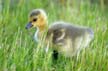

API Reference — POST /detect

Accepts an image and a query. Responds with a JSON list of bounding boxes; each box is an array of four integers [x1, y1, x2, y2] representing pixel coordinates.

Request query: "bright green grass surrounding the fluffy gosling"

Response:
[[0, 0, 108, 71]]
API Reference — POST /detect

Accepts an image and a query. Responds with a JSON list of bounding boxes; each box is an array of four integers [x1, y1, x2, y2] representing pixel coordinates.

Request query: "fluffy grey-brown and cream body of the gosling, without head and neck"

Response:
[[47, 22, 94, 57]]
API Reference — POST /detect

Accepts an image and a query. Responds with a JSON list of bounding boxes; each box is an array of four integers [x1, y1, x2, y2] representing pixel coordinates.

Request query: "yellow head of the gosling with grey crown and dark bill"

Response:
[[26, 9, 47, 31]]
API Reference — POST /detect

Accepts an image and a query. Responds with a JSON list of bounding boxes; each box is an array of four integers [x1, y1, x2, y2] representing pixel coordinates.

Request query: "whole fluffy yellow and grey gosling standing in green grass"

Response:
[[26, 9, 94, 57]]
